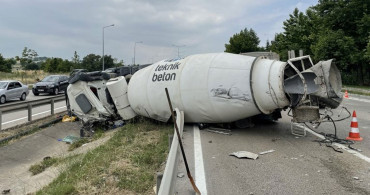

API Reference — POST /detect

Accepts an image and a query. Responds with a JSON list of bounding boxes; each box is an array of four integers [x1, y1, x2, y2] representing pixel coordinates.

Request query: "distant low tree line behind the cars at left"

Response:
[[0, 47, 123, 73]]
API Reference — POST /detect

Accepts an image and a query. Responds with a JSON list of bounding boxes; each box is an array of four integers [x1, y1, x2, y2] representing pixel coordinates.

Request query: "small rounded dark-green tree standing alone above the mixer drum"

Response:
[[225, 28, 260, 54]]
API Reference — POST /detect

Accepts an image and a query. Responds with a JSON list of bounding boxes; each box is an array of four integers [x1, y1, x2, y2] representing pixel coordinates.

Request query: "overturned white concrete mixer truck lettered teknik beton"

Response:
[[67, 53, 342, 136]]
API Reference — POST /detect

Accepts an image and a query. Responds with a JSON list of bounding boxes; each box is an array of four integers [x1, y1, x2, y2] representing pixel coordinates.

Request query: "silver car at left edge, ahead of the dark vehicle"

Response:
[[0, 80, 29, 104]]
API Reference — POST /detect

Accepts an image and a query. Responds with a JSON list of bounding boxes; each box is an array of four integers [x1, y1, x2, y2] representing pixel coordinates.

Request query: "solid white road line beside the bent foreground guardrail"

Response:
[[193, 125, 207, 195]]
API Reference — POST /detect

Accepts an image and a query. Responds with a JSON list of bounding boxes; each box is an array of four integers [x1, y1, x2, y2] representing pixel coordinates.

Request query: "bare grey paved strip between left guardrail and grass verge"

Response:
[[0, 122, 81, 194]]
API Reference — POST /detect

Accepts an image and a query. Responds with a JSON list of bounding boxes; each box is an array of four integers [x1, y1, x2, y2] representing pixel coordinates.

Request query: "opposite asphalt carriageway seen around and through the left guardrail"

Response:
[[0, 91, 66, 129]]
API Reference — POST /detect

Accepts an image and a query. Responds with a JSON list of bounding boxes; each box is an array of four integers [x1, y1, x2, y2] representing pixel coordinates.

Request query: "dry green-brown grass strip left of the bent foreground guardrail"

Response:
[[37, 120, 173, 194]]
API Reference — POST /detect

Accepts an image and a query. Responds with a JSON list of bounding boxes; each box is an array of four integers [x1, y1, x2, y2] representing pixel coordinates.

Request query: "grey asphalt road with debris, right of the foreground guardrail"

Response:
[[176, 96, 370, 195]]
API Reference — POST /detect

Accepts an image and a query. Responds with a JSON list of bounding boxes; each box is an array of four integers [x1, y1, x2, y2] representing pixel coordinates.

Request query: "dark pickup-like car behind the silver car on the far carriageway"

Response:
[[32, 75, 69, 95]]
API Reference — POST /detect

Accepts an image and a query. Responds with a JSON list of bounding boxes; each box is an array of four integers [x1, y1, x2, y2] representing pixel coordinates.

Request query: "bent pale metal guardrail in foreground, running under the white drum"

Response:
[[158, 108, 184, 195]]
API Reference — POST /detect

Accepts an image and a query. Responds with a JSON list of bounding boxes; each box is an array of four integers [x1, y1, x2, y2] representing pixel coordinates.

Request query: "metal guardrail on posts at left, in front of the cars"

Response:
[[0, 95, 65, 131]]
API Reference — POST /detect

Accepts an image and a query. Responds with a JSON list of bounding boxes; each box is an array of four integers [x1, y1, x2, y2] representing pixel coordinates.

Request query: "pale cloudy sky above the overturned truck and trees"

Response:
[[0, 0, 317, 64]]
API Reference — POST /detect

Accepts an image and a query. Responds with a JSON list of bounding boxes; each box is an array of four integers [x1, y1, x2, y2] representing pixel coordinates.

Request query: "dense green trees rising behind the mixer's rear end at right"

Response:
[[225, 0, 370, 85]]
